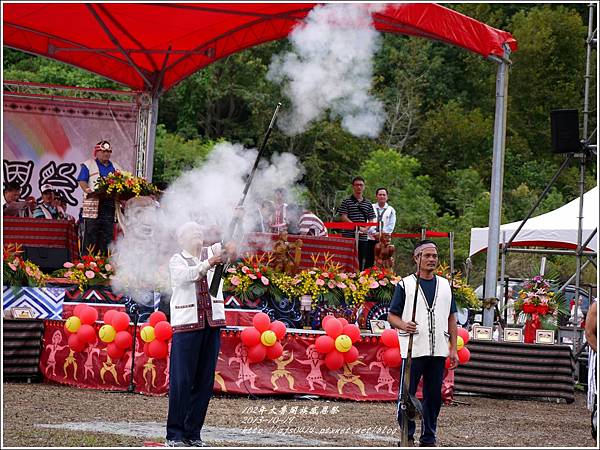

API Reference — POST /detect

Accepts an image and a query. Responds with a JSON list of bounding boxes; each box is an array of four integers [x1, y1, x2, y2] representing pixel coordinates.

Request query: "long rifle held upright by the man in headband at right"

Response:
[[397, 255, 423, 447]]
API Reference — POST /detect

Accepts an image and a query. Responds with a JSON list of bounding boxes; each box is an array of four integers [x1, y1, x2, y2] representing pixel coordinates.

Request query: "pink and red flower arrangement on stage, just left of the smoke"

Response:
[[52, 253, 114, 292]]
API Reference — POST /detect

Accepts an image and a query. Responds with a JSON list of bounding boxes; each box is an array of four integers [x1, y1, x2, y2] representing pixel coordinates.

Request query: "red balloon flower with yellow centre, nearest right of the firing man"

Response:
[[240, 312, 286, 363]]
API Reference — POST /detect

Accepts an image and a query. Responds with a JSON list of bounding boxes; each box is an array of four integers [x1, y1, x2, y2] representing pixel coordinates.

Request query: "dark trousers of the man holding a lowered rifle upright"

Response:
[[400, 356, 446, 444]]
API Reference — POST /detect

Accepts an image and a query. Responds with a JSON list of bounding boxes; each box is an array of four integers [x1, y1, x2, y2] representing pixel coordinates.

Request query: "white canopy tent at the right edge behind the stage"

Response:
[[469, 186, 598, 256]]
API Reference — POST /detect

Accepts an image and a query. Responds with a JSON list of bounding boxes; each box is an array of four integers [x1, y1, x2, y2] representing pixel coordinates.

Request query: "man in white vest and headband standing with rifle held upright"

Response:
[[388, 240, 458, 447]]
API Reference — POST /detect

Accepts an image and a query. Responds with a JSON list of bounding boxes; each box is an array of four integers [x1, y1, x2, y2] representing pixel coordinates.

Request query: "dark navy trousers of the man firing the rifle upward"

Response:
[[167, 327, 221, 441]]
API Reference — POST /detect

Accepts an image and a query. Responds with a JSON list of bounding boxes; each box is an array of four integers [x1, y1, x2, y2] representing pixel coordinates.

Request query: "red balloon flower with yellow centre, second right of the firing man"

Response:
[[315, 316, 361, 370]]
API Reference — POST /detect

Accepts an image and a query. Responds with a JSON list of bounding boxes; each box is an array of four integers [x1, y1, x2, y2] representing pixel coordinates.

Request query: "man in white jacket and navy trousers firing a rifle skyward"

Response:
[[166, 222, 235, 447]]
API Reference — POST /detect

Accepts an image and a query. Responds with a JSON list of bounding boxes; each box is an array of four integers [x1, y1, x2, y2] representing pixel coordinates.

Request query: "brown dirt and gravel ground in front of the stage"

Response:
[[2, 383, 595, 448]]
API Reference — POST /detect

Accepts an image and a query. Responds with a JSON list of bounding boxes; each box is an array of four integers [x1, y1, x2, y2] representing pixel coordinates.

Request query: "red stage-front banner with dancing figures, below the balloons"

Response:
[[40, 320, 454, 403]]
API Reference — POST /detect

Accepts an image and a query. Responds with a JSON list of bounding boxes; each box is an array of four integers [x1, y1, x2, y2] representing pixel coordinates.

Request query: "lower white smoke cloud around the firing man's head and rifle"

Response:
[[111, 143, 304, 302]]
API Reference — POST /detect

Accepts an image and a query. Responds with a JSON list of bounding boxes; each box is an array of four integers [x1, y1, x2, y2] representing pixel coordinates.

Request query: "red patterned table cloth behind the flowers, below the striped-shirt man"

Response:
[[242, 233, 358, 272]]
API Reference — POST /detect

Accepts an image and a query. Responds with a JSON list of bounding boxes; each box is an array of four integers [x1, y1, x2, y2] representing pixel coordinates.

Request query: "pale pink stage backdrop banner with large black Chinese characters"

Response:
[[2, 91, 139, 217]]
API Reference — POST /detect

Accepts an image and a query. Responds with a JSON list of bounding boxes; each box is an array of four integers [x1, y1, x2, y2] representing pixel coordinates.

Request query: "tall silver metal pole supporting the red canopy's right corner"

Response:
[[483, 45, 510, 326]]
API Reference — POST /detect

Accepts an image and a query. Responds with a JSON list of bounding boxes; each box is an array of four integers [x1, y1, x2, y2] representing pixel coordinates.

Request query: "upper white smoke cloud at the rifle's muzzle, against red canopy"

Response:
[[267, 3, 385, 137]]
